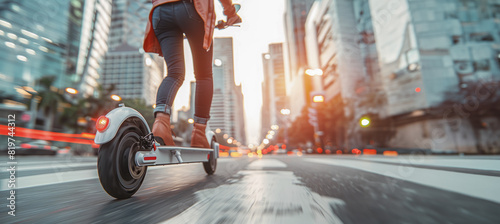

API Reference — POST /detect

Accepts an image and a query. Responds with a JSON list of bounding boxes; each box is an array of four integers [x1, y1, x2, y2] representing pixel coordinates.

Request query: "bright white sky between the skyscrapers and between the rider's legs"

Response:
[[174, 0, 285, 144]]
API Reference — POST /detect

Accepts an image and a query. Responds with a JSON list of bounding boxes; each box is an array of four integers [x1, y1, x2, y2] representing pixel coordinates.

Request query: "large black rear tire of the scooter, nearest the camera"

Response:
[[97, 125, 147, 199]]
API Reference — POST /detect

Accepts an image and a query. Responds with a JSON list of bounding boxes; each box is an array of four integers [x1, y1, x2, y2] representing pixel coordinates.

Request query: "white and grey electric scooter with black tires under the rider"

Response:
[[94, 4, 240, 199]]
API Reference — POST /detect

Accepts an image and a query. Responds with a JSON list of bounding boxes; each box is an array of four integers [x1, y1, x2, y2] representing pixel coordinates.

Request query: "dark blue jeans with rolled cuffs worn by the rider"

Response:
[[152, 0, 213, 124]]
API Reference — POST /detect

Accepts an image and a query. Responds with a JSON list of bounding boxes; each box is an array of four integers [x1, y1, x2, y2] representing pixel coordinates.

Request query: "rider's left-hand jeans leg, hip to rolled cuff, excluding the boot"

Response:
[[153, 3, 185, 115]]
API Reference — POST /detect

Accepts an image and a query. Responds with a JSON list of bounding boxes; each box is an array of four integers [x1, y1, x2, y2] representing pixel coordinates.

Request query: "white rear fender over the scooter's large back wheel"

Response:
[[94, 106, 151, 145]]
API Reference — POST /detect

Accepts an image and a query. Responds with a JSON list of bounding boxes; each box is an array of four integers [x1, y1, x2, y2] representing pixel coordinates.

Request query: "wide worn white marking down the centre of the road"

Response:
[[163, 159, 345, 224]]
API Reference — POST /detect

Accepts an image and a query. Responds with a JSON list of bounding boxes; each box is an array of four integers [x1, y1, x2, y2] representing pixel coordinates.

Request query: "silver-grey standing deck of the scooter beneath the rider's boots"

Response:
[[135, 143, 219, 166]]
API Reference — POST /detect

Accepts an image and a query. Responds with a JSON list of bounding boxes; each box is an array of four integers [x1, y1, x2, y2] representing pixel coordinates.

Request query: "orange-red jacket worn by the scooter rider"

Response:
[[143, 0, 236, 56]]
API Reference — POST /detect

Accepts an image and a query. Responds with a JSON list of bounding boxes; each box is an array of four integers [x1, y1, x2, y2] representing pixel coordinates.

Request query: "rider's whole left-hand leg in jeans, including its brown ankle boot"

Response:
[[152, 3, 185, 146]]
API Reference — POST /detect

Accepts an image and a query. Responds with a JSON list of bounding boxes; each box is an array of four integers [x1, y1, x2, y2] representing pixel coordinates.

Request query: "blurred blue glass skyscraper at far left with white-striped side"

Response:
[[0, 0, 111, 130]]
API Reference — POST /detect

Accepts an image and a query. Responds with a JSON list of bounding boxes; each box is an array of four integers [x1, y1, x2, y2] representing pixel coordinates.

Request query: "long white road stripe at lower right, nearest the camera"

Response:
[[305, 158, 500, 203]]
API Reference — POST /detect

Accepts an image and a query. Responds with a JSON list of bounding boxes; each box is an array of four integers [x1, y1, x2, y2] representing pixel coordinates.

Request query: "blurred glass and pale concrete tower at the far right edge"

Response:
[[370, 0, 500, 152]]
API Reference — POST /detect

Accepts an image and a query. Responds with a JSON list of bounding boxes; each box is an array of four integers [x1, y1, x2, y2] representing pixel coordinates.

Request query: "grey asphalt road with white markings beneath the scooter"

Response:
[[0, 155, 500, 223]]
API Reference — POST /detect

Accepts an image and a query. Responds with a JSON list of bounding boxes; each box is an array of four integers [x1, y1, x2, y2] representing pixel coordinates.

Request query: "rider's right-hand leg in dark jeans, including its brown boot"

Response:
[[177, 2, 214, 148]]
